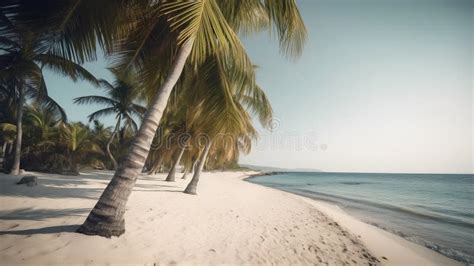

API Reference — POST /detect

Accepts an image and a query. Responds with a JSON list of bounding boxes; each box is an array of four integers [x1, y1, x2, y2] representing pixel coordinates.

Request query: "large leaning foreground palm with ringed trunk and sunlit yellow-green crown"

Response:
[[78, 0, 304, 237]]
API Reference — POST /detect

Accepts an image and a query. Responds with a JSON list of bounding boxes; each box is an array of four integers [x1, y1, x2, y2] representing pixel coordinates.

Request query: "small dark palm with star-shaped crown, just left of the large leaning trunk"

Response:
[[74, 69, 146, 169]]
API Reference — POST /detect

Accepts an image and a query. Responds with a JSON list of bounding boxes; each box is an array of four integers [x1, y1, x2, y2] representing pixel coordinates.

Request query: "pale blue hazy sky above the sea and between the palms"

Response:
[[42, 0, 474, 173]]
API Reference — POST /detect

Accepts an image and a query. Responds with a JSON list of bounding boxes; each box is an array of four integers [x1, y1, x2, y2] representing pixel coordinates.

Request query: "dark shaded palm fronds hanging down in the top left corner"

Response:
[[0, 0, 130, 63]]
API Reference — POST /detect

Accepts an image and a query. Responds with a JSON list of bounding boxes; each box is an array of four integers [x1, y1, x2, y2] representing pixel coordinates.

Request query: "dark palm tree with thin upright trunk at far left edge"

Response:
[[0, 12, 97, 175]]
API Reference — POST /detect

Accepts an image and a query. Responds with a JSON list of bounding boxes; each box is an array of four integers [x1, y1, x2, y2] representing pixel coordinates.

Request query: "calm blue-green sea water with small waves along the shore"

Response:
[[247, 172, 474, 264]]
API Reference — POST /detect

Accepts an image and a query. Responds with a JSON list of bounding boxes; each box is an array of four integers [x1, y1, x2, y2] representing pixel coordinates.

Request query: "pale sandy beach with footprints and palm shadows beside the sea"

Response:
[[0, 172, 456, 265]]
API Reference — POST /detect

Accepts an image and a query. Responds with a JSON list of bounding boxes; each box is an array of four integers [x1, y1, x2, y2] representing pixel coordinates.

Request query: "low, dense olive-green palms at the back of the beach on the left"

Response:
[[0, 92, 140, 175]]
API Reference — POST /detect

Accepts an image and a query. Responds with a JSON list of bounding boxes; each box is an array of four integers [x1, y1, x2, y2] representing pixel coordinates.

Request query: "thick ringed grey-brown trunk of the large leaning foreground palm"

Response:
[[77, 41, 193, 237]]
